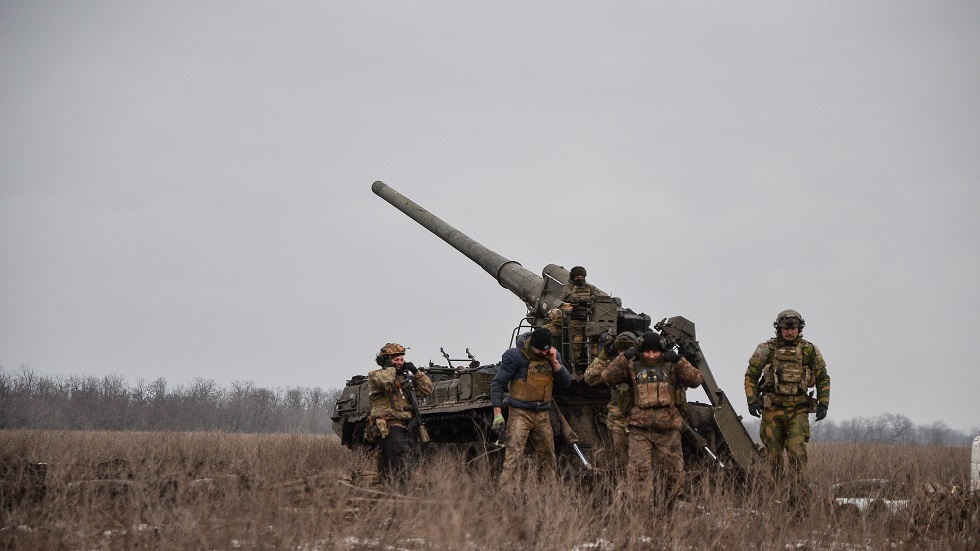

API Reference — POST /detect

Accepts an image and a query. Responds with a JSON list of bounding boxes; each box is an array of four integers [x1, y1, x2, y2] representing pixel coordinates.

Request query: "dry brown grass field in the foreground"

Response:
[[0, 431, 978, 551]]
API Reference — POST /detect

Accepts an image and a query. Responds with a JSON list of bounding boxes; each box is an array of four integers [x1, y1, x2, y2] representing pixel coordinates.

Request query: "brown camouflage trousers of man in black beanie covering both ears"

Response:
[[626, 427, 684, 505]]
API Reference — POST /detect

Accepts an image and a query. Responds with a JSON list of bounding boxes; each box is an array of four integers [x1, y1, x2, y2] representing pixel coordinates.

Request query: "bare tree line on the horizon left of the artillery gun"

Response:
[[0, 366, 341, 434]]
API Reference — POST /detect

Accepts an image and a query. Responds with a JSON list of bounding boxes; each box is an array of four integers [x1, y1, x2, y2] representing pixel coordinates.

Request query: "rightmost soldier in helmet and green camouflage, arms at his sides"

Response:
[[745, 310, 830, 503]]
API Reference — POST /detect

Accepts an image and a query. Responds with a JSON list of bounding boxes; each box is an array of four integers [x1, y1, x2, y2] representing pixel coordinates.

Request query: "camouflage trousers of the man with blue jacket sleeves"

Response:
[[500, 407, 558, 491]]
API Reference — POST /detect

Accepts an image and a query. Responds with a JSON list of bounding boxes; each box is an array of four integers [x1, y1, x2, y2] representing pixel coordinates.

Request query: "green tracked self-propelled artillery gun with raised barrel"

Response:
[[333, 181, 759, 471]]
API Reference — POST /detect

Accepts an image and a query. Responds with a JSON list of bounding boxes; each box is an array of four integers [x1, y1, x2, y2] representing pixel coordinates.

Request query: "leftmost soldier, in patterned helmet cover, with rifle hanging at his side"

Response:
[[368, 343, 432, 491]]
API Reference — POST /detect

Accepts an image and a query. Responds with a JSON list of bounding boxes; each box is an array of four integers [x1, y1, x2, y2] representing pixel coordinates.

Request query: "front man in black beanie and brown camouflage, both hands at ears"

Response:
[[602, 332, 704, 509]]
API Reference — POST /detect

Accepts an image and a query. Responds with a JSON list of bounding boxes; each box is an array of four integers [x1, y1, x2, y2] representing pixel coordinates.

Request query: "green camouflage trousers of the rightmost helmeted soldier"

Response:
[[759, 403, 810, 499]]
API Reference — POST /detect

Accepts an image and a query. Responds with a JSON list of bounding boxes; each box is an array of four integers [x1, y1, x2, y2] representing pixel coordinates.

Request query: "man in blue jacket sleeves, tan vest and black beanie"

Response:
[[490, 327, 572, 490]]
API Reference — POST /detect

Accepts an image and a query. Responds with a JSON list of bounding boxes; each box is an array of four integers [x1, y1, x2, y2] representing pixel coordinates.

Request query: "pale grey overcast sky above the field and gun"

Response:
[[0, 0, 980, 436]]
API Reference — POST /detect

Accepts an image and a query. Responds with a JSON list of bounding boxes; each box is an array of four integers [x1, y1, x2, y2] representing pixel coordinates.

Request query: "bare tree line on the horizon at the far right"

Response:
[[745, 413, 980, 446]]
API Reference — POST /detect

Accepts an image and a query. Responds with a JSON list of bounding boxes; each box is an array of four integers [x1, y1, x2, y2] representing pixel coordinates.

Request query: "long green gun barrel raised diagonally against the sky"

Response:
[[371, 181, 568, 316]]
